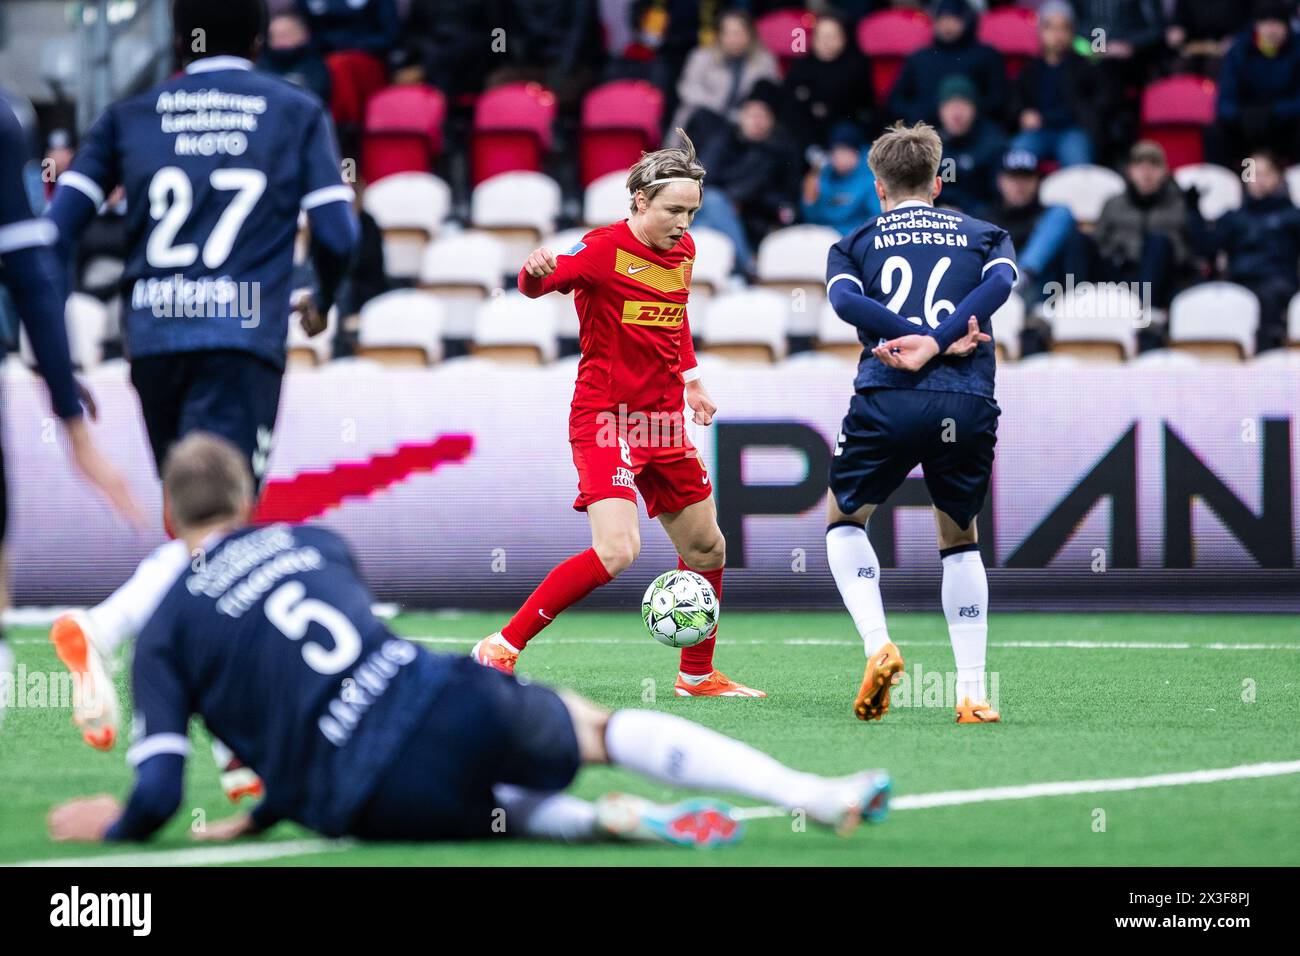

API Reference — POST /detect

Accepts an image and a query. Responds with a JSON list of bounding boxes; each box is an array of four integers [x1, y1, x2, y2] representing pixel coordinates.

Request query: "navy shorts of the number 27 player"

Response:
[[131, 349, 285, 488]]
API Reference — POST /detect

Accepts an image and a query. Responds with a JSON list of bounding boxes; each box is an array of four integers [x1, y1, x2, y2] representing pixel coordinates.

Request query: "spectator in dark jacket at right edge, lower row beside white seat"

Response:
[[1191, 150, 1300, 351]]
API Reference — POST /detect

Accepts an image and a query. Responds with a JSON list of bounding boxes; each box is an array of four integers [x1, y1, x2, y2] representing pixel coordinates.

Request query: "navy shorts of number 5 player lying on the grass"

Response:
[[350, 657, 582, 840]]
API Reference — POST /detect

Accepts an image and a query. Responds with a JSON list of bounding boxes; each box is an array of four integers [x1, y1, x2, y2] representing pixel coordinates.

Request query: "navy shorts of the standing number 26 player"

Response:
[[831, 389, 1002, 528]]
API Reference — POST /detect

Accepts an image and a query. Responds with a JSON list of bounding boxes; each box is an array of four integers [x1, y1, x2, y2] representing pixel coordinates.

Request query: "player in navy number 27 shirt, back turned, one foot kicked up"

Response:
[[48, 0, 358, 799]]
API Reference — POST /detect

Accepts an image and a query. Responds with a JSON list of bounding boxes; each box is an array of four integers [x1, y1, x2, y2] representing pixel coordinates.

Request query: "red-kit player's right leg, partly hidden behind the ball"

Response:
[[659, 498, 767, 697]]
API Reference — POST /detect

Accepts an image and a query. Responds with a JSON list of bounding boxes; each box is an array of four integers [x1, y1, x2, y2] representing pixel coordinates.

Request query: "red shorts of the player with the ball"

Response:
[[569, 416, 714, 518]]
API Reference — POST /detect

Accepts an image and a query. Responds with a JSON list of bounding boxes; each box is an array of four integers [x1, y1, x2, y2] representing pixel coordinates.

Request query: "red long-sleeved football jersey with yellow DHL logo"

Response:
[[519, 220, 696, 423]]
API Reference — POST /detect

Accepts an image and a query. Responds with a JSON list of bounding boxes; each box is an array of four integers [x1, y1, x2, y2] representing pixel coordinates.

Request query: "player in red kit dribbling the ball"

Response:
[[472, 130, 767, 697]]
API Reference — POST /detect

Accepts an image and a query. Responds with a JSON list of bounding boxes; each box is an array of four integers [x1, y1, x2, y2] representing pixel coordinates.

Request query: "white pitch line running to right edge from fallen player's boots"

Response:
[[736, 760, 1300, 819]]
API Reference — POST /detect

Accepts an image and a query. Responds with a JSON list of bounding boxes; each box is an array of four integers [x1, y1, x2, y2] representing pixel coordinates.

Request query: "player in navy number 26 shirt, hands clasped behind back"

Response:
[[826, 124, 1017, 723]]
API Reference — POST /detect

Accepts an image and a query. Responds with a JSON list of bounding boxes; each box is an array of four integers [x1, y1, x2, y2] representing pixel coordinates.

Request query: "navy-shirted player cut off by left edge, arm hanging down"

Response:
[[0, 95, 143, 721]]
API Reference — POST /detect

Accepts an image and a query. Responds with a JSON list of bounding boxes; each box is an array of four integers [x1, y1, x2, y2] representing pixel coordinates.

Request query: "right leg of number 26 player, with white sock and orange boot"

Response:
[[935, 510, 1002, 723]]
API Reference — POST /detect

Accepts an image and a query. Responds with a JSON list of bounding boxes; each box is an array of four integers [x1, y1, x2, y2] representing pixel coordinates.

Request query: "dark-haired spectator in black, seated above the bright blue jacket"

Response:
[[783, 14, 875, 148]]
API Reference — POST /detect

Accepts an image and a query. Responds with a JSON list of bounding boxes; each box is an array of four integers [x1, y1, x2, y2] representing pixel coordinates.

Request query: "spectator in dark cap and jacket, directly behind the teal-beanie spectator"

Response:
[[887, 0, 1006, 122]]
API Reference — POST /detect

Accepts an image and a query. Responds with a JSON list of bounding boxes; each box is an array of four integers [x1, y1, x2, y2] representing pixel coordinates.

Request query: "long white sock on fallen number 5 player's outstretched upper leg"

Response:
[[605, 710, 827, 808]]
